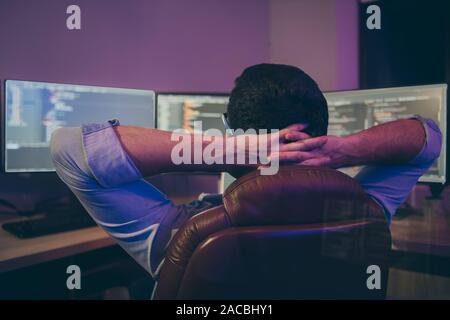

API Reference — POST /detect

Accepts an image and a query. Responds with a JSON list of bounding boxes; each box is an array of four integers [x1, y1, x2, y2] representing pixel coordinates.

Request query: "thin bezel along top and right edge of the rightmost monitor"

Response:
[[323, 83, 450, 185]]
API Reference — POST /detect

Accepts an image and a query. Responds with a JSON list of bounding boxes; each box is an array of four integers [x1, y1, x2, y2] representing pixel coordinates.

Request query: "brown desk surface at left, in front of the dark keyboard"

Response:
[[0, 195, 197, 273]]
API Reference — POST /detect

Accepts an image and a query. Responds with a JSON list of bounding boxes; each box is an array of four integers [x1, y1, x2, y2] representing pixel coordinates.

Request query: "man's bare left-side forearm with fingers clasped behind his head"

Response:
[[114, 124, 316, 176]]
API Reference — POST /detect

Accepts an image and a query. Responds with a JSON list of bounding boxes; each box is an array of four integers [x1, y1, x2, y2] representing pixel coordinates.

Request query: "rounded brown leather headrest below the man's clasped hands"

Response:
[[223, 165, 384, 225]]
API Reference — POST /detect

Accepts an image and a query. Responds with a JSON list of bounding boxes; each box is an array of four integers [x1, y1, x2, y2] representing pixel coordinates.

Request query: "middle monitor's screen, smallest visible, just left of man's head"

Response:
[[156, 94, 228, 134]]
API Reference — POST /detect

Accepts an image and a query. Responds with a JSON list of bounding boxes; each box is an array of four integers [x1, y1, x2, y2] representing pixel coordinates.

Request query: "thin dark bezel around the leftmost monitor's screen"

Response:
[[0, 78, 157, 175]]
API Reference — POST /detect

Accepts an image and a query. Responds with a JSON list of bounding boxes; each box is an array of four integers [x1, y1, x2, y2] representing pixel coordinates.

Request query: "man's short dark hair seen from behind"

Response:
[[227, 64, 328, 136]]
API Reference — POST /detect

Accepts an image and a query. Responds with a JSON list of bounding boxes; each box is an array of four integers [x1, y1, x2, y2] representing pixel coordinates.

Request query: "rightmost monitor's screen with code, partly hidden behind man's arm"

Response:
[[325, 84, 447, 183]]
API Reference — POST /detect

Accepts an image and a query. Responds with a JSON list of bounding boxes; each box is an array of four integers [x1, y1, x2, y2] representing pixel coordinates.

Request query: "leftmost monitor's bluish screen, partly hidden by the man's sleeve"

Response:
[[3, 80, 155, 172]]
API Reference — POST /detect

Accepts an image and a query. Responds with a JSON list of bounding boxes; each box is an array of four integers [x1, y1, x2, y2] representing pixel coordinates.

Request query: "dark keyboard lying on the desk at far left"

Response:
[[3, 210, 96, 238]]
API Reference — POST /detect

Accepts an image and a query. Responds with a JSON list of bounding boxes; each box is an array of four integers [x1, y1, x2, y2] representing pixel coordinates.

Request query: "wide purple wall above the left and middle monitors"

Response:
[[0, 0, 268, 91]]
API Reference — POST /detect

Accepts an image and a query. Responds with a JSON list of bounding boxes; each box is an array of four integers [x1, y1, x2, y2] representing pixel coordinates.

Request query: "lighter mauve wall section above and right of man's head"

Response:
[[269, 0, 359, 91]]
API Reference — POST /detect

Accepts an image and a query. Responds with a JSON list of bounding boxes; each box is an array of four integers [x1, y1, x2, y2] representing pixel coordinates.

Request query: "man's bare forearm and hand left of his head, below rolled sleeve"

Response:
[[114, 124, 326, 176]]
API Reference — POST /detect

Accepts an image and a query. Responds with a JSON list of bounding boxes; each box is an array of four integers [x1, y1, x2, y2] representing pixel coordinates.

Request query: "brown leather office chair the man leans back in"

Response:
[[154, 166, 391, 299]]
